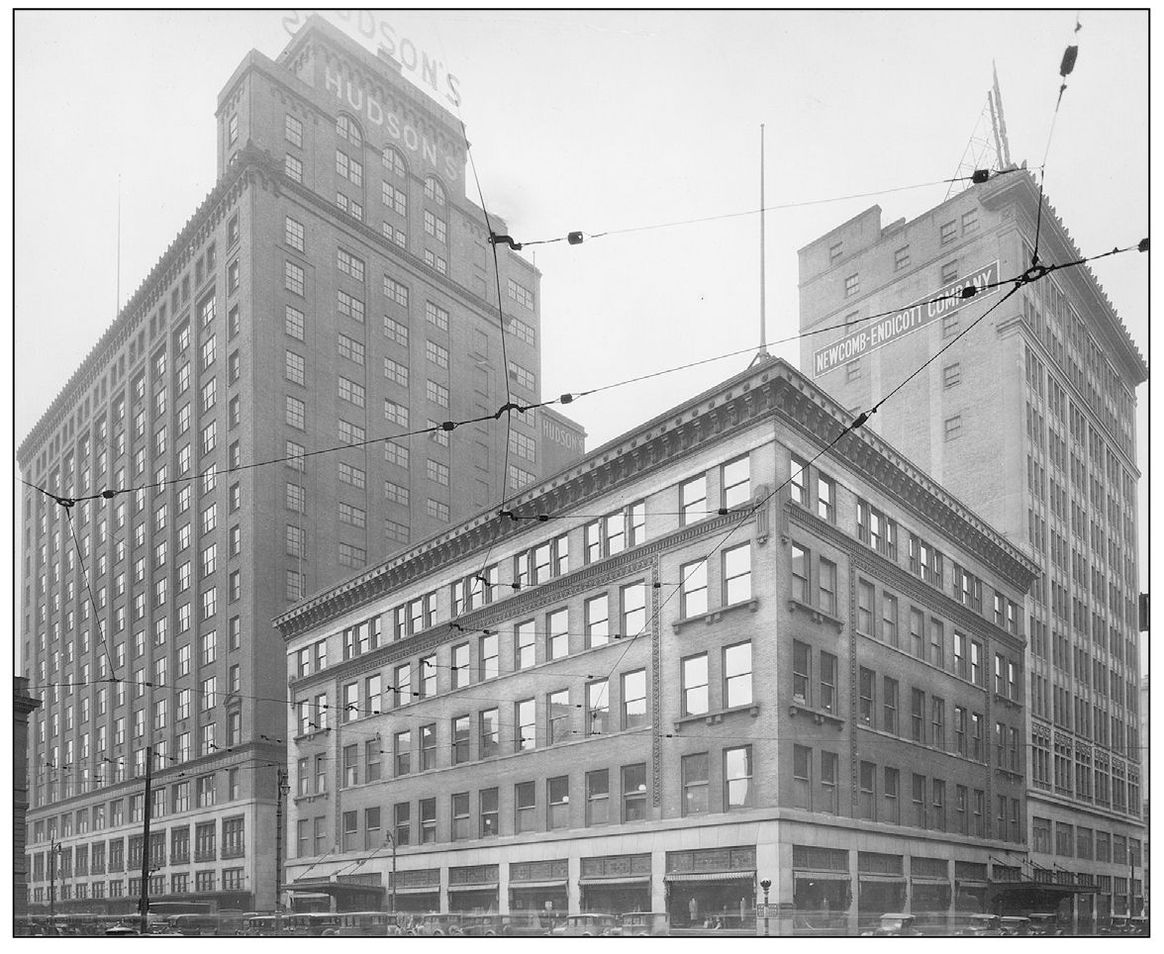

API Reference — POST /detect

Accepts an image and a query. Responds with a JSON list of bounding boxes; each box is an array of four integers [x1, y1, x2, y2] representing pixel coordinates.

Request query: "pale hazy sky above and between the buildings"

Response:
[[13, 9, 1150, 656]]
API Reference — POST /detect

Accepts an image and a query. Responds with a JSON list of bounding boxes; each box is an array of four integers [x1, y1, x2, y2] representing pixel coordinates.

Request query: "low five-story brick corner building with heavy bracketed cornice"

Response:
[[277, 359, 1035, 933]]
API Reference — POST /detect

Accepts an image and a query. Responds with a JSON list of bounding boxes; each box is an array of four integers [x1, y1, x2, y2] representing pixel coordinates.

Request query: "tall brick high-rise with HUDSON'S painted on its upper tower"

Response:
[[19, 17, 583, 911]]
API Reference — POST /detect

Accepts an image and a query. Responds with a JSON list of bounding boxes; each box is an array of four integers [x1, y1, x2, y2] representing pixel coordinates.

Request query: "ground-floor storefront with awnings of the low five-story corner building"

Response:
[[279, 813, 1017, 935]]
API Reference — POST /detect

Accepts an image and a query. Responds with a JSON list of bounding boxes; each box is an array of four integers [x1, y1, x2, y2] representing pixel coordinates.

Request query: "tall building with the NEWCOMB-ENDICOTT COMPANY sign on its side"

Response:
[[800, 170, 1148, 927]]
